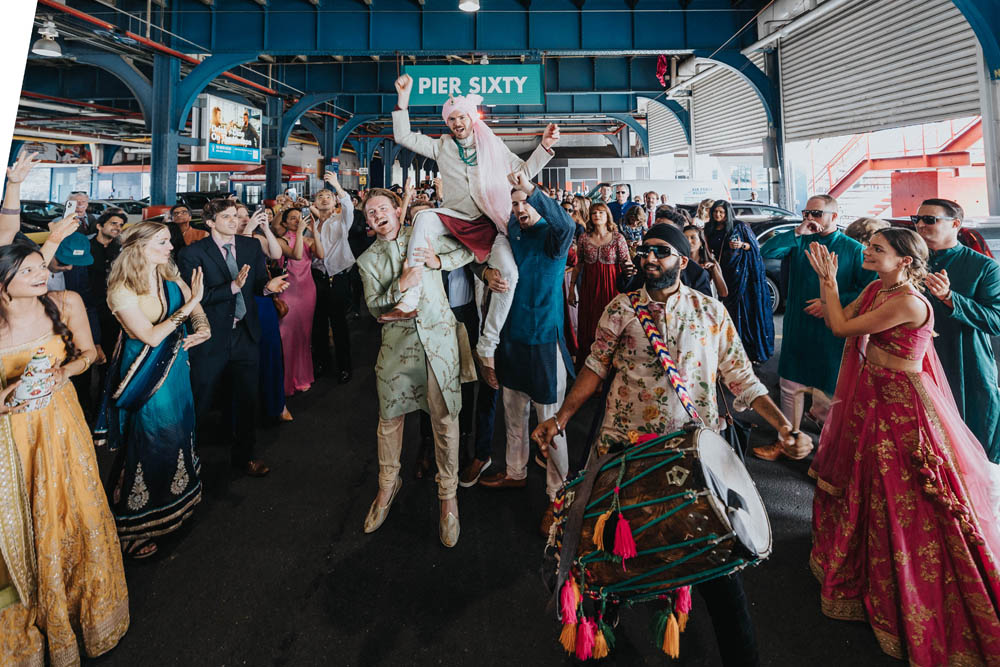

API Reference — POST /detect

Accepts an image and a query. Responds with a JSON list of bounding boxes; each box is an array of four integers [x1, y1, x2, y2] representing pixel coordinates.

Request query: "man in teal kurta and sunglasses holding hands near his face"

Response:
[[753, 195, 876, 461]]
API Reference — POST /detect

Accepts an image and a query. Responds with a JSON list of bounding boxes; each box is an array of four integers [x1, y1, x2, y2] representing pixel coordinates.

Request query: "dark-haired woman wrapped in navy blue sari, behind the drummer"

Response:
[[705, 200, 774, 363]]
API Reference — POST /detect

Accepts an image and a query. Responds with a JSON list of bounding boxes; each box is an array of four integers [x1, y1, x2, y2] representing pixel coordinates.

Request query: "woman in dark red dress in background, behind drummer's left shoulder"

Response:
[[569, 203, 635, 371]]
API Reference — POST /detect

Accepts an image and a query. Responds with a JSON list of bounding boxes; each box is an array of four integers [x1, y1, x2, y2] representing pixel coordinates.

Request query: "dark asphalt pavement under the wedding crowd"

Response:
[[87, 316, 898, 667]]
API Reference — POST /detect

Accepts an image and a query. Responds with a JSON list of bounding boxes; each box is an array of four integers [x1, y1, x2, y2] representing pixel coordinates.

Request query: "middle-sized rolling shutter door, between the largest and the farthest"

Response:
[[691, 53, 767, 154]]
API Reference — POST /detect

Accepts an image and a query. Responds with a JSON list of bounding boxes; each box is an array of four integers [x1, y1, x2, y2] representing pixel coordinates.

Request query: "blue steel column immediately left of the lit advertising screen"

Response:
[[149, 54, 181, 205]]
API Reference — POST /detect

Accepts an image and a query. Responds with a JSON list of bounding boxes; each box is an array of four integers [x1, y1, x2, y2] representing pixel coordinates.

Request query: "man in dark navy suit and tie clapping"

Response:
[[177, 199, 288, 477]]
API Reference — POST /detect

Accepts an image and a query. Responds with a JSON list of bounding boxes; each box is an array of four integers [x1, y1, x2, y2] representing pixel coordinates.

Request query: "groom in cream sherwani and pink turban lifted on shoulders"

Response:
[[379, 74, 559, 388]]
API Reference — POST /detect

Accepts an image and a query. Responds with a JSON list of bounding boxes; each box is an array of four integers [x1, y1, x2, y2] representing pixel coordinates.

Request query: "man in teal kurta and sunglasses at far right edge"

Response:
[[912, 199, 1000, 463]]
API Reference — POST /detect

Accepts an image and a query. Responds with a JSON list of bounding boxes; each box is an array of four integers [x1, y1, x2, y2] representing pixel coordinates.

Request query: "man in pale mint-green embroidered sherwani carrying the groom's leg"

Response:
[[358, 189, 473, 547]]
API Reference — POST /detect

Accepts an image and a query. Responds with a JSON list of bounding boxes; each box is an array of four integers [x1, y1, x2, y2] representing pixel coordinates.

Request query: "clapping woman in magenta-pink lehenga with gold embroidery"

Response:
[[809, 228, 1000, 667]]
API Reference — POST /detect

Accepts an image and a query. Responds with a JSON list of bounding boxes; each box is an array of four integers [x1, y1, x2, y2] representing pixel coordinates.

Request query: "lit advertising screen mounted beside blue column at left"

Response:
[[191, 93, 261, 164]]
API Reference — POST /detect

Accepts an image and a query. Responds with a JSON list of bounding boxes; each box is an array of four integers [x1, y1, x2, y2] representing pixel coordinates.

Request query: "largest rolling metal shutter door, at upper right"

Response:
[[779, 0, 979, 141]]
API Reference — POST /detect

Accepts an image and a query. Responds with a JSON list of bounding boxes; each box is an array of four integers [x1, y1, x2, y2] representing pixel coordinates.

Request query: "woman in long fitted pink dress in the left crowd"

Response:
[[278, 208, 323, 396]]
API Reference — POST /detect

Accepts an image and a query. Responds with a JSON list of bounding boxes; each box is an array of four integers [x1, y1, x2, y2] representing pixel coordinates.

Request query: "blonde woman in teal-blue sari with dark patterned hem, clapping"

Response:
[[96, 222, 211, 558]]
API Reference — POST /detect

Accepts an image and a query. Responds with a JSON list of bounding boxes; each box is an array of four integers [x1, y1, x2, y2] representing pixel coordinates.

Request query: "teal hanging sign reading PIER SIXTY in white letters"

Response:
[[403, 65, 545, 106]]
